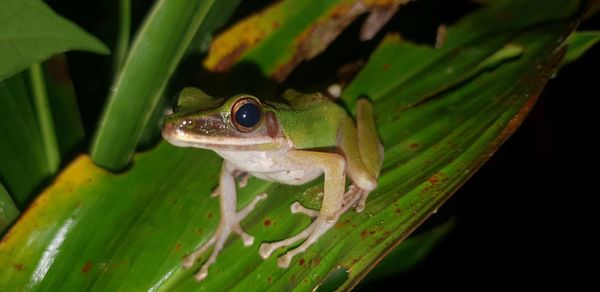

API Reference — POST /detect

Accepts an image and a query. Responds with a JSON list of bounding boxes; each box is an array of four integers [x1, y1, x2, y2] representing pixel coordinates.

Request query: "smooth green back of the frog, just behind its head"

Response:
[[270, 90, 350, 149]]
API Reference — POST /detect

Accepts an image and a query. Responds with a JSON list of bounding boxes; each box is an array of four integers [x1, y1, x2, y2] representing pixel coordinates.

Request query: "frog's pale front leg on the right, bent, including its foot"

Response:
[[259, 151, 346, 268]]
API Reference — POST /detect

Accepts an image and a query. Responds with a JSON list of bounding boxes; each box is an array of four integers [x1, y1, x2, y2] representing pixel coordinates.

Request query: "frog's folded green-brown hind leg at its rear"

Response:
[[340, 99, 383, 212]]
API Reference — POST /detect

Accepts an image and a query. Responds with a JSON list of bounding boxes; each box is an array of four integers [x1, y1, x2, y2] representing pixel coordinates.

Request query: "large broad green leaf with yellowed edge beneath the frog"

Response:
[[0, 0, 578, 291]]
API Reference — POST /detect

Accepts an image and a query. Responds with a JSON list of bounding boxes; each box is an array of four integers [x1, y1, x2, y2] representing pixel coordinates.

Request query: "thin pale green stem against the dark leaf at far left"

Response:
[[29, 63, 60, 174]]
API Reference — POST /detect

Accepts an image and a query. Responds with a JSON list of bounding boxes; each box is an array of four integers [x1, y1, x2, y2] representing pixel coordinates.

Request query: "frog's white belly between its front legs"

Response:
[[216, 151, 323, 185]]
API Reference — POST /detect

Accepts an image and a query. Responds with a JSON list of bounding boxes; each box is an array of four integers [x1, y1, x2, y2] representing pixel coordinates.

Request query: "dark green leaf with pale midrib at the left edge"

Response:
[[0, 56, 83, 207]]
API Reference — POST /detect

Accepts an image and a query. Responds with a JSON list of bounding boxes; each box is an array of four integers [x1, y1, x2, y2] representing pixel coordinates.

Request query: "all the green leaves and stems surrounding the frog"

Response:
[[0, 0, 597, 290]]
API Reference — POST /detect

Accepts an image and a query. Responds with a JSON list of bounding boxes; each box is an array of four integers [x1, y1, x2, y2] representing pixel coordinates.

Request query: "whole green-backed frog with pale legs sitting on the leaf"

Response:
[[162, 87, 383, 281]]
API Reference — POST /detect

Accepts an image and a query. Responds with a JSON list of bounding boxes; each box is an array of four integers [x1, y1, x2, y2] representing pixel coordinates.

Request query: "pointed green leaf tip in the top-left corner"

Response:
[[0, 0, 109, 80]]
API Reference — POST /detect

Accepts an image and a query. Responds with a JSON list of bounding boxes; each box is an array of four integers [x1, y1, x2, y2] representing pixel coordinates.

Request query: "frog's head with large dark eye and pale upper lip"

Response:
[[162, 87, 288, 151]]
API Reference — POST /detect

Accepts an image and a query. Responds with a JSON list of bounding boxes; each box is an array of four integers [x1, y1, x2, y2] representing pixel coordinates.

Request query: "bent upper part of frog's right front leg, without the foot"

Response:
[[289, 150, 346, 220]]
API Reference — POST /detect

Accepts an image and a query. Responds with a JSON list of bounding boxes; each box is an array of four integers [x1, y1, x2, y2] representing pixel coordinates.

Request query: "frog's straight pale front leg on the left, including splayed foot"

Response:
[[183, 161, 267, 281]]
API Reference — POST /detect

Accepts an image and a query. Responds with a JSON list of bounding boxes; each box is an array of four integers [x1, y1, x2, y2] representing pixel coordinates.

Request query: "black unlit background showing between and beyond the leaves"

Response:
[[47, 0, 600, 291]]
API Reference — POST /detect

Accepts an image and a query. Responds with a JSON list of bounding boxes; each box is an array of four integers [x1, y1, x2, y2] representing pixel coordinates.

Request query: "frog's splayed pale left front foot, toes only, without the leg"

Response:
[[182, 194, 267, 281]]
